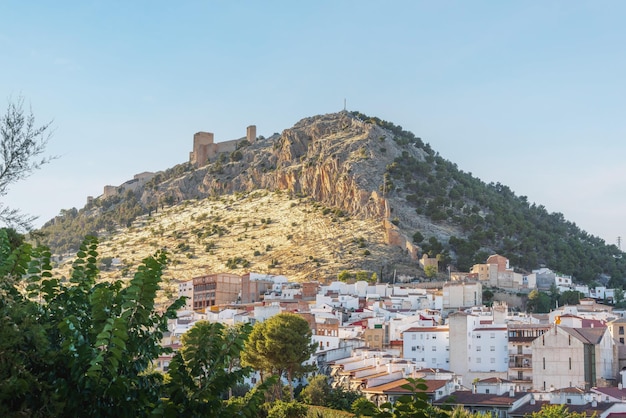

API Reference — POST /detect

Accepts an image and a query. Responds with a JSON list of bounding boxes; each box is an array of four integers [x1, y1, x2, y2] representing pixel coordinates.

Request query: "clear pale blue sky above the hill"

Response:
[[0, 0, 626, 246]]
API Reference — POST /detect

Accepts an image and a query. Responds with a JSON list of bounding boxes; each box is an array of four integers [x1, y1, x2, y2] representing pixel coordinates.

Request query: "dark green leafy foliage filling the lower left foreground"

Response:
[[0, 233, 266, 417]]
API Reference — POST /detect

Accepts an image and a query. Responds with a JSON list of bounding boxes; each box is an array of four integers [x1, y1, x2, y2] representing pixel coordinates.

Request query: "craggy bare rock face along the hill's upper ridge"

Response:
[[143, 112, 458, 259]]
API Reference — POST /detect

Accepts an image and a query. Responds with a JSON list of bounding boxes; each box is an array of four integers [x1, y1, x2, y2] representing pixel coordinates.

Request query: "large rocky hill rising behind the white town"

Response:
[[40, 112, 626, 285]]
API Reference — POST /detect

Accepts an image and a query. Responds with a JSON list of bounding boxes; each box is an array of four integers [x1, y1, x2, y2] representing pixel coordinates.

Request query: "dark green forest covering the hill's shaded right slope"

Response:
[[355, 112, 626, 285]]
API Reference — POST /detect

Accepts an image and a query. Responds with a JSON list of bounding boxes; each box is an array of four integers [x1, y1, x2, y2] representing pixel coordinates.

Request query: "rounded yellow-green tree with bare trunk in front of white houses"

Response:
[[242, 313, 317, 399]]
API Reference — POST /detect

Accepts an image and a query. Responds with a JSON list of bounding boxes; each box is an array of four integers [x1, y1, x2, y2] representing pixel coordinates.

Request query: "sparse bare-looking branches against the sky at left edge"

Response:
[[0, 98, 56, 230]]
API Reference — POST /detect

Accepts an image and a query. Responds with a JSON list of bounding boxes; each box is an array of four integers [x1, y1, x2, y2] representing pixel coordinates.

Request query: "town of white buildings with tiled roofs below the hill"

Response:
[[157, 255, 626, 418]]
